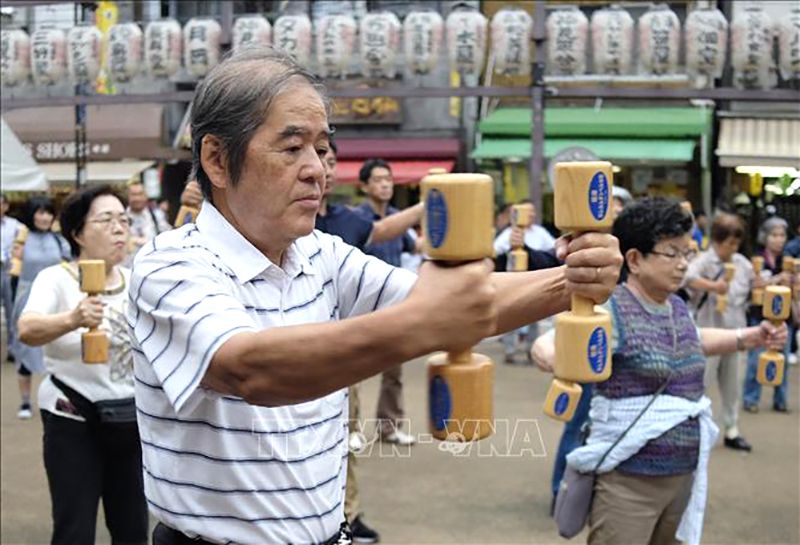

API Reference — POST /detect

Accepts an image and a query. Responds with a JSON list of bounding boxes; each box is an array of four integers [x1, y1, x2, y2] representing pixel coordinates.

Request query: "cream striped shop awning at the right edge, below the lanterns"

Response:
[[716, 118, 800, 168]]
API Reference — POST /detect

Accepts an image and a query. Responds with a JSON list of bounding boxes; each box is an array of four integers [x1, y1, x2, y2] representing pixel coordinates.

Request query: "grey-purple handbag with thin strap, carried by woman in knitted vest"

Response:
[[553, 372, 672, 539]]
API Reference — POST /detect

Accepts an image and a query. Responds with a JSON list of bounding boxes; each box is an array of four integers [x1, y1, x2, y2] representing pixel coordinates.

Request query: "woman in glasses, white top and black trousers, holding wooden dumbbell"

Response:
[[19, 186, 147, 544]]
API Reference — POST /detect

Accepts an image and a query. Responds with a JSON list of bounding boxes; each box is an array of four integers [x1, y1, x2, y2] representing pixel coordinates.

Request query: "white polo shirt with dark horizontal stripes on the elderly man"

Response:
[[128, 202, 416, 544]]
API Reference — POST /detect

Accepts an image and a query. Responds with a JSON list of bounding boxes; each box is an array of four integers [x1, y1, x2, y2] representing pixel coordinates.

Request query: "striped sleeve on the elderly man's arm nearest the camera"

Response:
[[128, 250, 259, 412]]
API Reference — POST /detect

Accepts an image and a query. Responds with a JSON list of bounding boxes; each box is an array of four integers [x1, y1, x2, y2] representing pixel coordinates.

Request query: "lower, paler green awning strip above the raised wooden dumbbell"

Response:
[[470, 138, 696, 163]]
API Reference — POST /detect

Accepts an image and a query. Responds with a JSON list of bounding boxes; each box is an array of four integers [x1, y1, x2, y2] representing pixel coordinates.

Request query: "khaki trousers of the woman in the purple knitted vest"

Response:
[[588, 471, 694, 545]]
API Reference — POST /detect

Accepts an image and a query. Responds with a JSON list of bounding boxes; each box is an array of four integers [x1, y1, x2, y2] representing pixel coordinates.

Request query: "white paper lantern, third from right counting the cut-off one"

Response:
[[684, 9, 728, 78]]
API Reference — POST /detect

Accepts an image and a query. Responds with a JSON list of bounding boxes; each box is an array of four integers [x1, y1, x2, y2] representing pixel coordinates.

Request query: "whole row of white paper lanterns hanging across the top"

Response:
[[0, 4, 800, 86]]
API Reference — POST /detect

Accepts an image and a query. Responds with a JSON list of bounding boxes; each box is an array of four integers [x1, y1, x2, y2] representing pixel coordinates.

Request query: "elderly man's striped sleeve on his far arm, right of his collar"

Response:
[[333, 237, 417, 318]]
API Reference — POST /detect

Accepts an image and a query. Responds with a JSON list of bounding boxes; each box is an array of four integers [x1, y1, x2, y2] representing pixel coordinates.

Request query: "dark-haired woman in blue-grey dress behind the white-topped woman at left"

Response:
[[11, 197, 69, 420]]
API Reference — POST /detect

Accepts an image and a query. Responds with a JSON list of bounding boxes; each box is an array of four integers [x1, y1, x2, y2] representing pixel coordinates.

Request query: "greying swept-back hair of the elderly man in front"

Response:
[[189, 45, 329, 201]]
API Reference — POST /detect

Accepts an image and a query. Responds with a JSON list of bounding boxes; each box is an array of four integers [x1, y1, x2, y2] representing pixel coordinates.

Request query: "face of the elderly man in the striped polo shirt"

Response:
[[222, 83, 329, 248]]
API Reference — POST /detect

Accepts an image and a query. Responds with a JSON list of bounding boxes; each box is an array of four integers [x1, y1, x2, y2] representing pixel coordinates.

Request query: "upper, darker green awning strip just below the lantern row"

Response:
[[479, 107, 713, 138]]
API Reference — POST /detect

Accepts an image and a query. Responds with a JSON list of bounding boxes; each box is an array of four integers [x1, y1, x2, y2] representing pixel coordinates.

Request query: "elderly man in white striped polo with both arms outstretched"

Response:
[[128, 46, 621, 545]]
